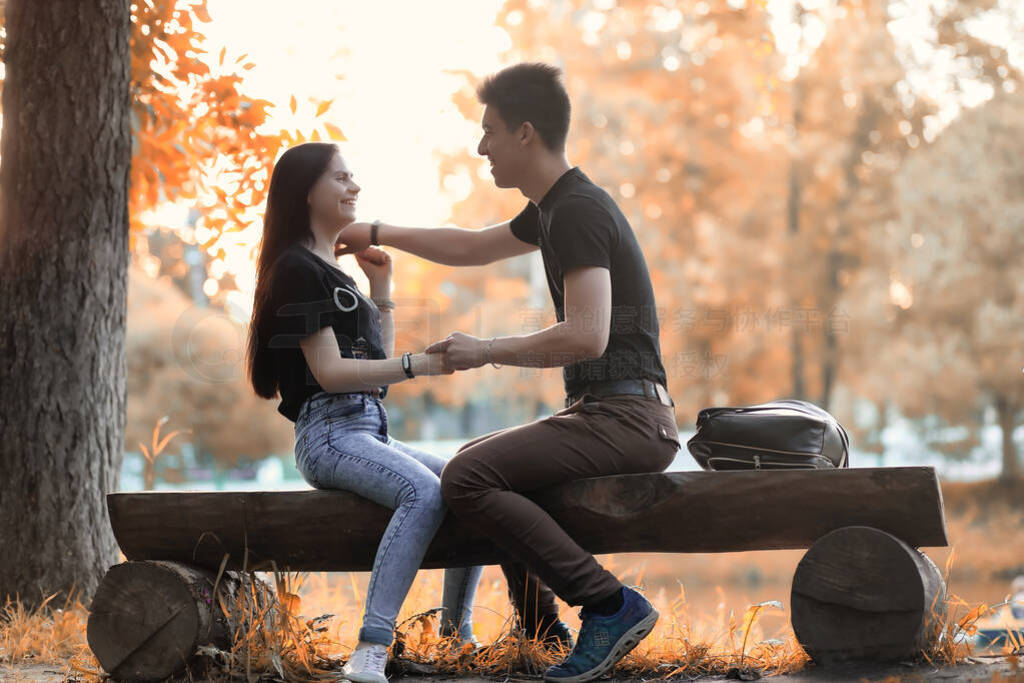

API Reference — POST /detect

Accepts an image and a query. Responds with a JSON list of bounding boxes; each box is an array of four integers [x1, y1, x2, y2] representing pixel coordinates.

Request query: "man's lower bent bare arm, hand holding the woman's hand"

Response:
[[426, 266, 611, 370]]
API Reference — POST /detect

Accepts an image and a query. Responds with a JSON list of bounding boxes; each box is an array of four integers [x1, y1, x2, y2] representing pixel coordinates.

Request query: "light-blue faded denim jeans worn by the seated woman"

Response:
[[295, 391, 483, 645]]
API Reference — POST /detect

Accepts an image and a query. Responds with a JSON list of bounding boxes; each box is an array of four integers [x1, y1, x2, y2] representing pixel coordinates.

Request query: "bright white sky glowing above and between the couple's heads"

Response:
[[204, 0, 509, 223]]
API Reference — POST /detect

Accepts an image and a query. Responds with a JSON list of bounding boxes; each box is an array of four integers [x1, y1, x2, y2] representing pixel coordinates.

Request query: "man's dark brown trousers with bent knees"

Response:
[[441, 394, 679, 624]]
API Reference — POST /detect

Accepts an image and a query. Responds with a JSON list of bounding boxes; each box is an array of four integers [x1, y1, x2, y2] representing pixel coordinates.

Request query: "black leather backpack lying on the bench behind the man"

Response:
[[686, 398, 850, 470]]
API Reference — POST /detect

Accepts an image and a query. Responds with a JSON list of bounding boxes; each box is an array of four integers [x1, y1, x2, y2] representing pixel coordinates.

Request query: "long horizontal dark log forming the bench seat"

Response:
[[106, 467, 947, 571]]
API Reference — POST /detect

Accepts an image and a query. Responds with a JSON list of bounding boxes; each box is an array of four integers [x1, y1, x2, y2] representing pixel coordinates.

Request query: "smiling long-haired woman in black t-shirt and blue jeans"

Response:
[[247, 142, 482, 683]]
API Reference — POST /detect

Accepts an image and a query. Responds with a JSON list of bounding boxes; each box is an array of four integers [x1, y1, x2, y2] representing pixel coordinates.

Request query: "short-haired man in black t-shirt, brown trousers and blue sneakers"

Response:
[[338, 63, 679, 683]]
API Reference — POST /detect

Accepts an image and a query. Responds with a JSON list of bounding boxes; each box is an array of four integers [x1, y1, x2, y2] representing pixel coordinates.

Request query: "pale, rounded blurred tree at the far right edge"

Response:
[[874, 92, 1024, 479]]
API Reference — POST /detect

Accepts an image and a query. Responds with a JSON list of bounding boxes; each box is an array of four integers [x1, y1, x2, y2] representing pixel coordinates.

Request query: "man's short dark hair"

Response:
[[476, 62, 570, 152]]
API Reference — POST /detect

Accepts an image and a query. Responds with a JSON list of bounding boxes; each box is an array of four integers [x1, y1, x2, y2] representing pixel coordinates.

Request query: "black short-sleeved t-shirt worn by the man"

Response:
[[511, 167, 667, 395]]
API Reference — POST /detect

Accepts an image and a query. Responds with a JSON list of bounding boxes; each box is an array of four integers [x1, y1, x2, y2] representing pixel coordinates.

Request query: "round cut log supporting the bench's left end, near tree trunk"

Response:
[[86, 561, 274, 681]]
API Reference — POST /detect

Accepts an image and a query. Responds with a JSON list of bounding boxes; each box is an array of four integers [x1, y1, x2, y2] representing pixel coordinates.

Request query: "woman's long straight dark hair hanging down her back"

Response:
[[246, 142, 338, 398]]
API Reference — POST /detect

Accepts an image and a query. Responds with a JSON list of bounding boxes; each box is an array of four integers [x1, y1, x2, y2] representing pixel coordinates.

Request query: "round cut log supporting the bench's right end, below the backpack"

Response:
[[790, 526, 946, 665]]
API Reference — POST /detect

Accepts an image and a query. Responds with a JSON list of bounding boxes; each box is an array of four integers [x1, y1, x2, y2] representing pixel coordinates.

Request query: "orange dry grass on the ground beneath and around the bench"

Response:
[[0, 555, 1021, 681]]
